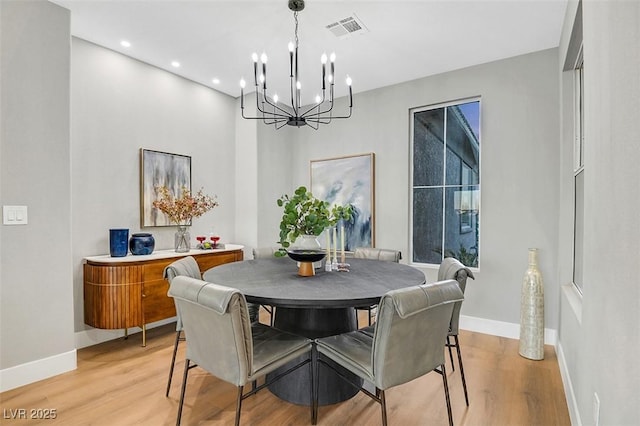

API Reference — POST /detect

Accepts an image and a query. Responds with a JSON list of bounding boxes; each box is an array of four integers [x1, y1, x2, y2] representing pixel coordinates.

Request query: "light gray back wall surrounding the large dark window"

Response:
[[260, 49, 560, 329]]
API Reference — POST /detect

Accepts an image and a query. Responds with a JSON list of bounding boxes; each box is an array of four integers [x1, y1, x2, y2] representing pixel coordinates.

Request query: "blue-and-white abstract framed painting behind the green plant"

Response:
[[311, 152, 375, 251]]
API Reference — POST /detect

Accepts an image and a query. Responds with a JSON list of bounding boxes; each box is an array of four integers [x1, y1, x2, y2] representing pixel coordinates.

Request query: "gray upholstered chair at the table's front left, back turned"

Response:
[[169, 276, 315, 426]]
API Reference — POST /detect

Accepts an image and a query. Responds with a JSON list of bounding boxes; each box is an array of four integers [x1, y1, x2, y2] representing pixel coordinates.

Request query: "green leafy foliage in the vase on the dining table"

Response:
[[276, 186, 353, 256]]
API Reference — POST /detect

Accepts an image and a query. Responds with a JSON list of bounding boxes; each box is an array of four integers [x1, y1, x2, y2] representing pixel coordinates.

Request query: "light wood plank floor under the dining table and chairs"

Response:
[[0, 312, 570, 426]]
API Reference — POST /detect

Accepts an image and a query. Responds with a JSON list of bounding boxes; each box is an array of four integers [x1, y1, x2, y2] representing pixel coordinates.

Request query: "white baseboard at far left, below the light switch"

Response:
[[0, 349, 77, 392]]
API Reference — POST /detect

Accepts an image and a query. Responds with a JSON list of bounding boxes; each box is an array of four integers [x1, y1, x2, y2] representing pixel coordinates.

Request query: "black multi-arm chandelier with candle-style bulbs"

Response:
[[240, 0, 353, 130]]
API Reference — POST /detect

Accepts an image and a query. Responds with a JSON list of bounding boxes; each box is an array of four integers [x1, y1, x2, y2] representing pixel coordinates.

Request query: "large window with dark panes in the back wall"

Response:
[[410, 99, 480, 267]]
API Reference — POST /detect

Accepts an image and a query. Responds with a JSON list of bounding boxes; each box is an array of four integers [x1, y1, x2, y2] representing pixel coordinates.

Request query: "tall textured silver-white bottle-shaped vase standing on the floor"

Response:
[[519, 248, 544, 360]]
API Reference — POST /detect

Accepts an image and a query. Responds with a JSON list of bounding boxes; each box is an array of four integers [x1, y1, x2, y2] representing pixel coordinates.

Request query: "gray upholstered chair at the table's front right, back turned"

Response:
[[312, 280, 464, 425]]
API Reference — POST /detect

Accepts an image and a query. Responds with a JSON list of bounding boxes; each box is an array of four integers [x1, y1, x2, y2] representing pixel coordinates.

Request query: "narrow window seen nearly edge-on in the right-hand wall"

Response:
[[573, 51, 584, 293]]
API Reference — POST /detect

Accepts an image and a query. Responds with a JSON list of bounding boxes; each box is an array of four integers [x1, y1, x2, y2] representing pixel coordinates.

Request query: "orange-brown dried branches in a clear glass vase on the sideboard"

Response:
[[153, 186, 218, 253]]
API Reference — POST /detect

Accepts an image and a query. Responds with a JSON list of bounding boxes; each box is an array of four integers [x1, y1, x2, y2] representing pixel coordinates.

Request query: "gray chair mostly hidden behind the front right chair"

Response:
[[438, 257, 475, 406]]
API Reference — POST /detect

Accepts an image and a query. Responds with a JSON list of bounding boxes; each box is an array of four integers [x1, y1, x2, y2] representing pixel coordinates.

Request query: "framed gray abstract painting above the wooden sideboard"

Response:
[[140, 149, 191, 227]]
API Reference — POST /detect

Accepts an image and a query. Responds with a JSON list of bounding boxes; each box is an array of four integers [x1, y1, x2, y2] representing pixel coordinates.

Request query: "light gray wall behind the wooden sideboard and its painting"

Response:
[[71, 38, 236, 331]]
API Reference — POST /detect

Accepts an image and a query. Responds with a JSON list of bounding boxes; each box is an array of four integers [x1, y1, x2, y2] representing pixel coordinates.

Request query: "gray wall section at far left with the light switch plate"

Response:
[[0, 1, 76, 380]]
